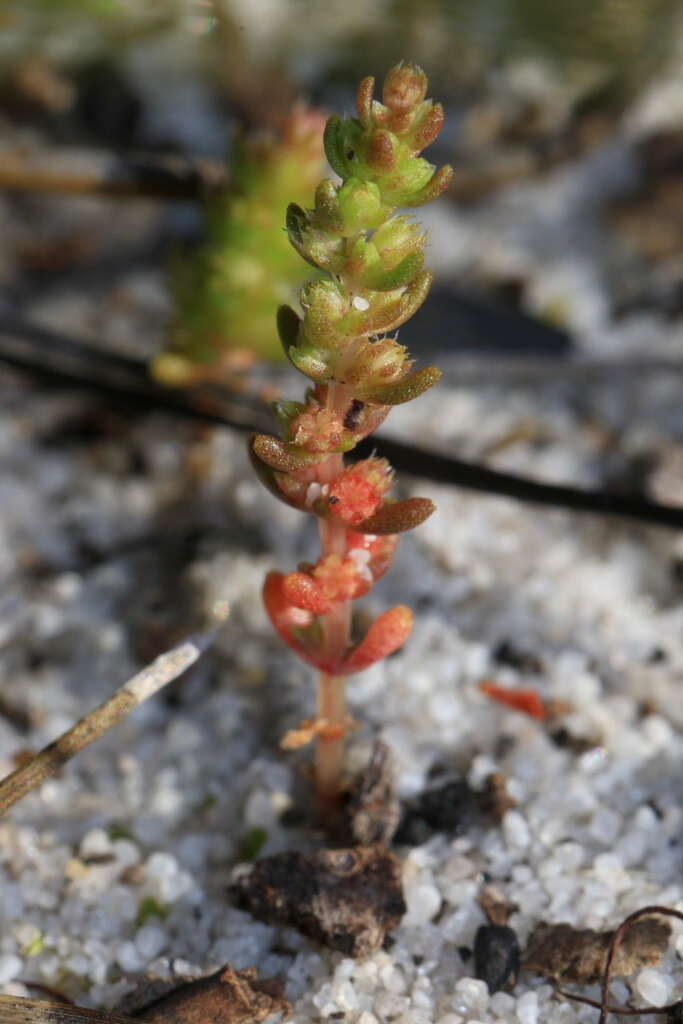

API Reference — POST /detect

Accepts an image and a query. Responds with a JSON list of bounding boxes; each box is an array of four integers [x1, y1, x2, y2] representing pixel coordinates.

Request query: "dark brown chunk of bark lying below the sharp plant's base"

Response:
[[232, 845, 405, 956]]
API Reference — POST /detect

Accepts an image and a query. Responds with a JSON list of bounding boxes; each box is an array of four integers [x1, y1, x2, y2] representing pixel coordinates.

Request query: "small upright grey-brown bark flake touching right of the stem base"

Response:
[[347, 740, 400, 846]]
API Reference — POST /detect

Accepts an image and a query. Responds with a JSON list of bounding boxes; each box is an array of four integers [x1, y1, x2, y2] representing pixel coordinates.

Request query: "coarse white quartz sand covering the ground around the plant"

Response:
[[0, 354, 683, 1024]]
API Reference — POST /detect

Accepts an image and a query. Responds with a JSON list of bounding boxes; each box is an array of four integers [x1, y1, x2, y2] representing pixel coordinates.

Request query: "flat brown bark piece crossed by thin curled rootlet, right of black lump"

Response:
[[522, 919, 671, 984]]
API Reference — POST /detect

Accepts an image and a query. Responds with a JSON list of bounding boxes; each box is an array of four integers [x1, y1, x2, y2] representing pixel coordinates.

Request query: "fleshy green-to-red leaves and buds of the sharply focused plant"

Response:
[[251, 65, 453, 676]]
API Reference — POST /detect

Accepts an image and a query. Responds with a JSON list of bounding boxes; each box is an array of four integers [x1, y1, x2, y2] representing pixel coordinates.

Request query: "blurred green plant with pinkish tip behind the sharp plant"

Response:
[[153, 103, 325, 385]]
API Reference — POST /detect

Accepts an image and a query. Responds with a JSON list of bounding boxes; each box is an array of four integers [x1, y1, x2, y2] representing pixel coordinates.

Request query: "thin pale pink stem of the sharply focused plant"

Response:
[[314, 384, 351, 799]]
